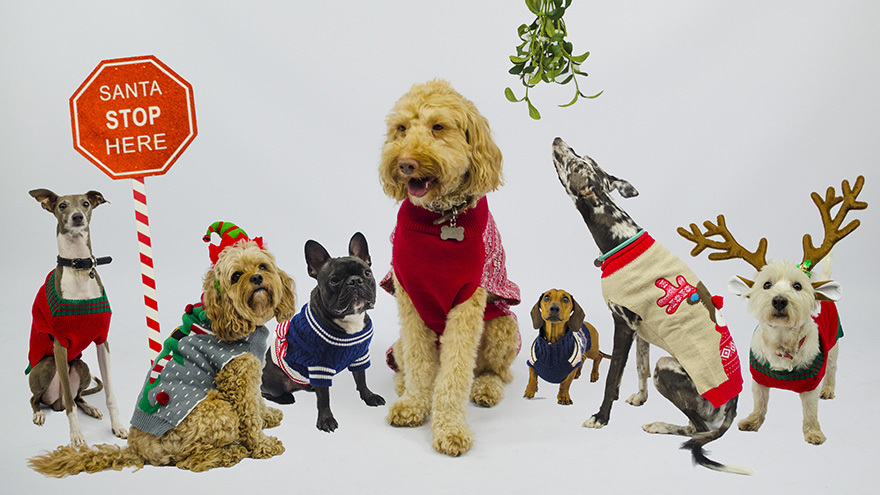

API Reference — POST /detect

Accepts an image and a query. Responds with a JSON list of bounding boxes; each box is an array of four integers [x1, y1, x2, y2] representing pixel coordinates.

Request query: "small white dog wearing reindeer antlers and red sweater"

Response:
[[678, 176, 868, 445]]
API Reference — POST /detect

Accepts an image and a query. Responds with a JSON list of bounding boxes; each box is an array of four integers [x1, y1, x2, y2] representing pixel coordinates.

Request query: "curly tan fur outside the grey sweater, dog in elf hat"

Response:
[[28, 241, 296, 477]]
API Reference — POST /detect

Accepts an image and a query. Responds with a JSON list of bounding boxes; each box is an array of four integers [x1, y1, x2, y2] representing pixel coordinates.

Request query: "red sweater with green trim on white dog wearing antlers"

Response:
[[749, 301, 843, 393]]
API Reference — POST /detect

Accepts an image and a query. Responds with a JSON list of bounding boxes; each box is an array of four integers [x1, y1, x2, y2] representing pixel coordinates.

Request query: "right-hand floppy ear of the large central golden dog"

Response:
[[463, 106, 503, 197]]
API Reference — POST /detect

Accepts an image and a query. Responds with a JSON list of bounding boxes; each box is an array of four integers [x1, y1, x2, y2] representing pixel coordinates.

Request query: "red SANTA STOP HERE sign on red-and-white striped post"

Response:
[[70, 55, 198, 363]]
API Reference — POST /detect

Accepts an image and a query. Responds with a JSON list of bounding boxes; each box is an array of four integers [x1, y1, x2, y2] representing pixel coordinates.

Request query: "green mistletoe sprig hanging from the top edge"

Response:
[[504, 0, 602, 120]]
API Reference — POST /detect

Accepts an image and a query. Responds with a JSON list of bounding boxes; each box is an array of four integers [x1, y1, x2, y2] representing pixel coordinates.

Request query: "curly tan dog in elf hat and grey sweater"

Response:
[[28, 222, 296, 477]]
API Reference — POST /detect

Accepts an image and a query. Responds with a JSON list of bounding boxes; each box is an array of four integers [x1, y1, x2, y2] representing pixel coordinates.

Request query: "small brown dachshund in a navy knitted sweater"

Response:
[[523, 289, 611, 406]]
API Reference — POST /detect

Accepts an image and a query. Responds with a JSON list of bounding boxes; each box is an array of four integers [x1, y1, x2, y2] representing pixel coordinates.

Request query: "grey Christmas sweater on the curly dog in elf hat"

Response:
[[131, 304, 269, 437]]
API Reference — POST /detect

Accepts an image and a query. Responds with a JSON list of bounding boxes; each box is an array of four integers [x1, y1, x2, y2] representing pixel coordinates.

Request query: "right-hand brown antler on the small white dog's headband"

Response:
[[802, 175, 868, 266]]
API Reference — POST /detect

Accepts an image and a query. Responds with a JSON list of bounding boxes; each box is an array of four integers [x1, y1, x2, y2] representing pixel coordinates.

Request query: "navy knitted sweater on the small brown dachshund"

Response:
[[526, 325, 592, 383]]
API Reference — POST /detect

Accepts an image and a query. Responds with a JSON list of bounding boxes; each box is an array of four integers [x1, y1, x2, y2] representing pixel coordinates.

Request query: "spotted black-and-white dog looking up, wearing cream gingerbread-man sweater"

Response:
[[553, 138, 751, 474]]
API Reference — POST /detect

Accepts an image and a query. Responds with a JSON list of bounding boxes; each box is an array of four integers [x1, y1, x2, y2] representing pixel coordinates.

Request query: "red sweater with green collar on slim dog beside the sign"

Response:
[[25, 270, 111, 374]]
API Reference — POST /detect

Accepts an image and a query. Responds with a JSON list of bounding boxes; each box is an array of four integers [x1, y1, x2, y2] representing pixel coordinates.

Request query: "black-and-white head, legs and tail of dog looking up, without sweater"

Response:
[[553, 138, 751, 474]]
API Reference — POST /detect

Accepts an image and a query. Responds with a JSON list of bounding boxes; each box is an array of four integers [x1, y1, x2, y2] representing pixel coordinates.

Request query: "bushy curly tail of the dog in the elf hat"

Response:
[[28, 444, 144, 478]]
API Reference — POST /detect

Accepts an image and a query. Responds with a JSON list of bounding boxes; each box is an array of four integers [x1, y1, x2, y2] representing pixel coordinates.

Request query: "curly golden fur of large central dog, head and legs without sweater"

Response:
[[379, 81, 519, 456]]
